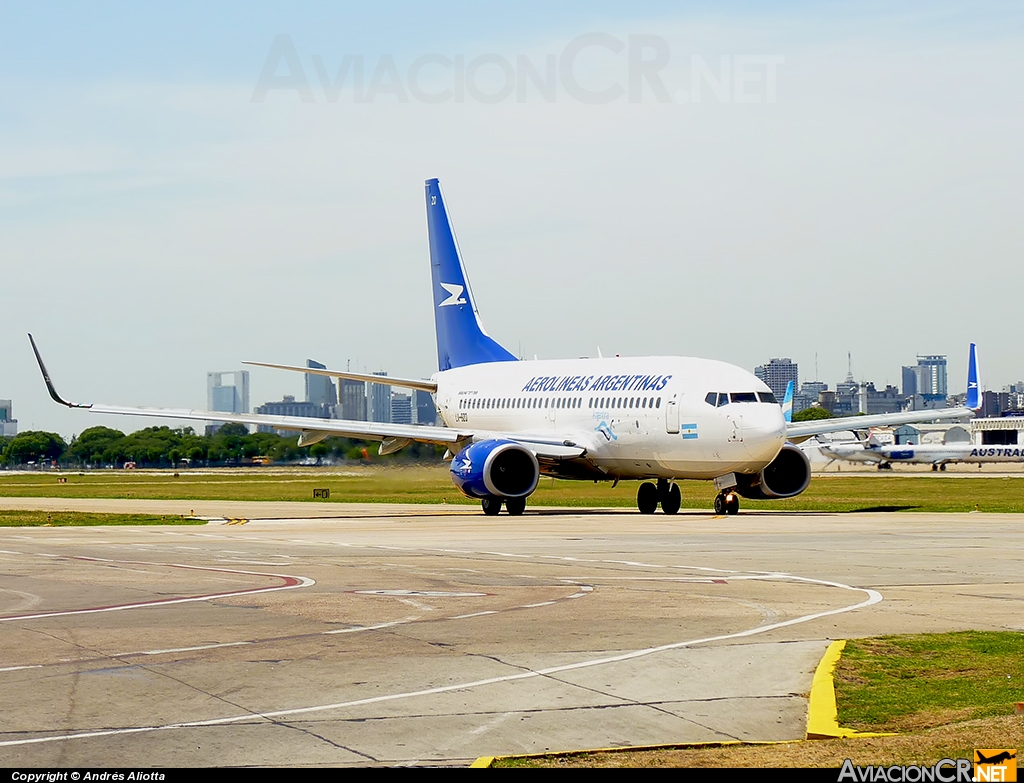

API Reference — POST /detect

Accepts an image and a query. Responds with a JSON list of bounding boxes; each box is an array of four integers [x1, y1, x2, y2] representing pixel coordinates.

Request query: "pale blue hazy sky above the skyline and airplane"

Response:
[[0, 1, 1024, 437]]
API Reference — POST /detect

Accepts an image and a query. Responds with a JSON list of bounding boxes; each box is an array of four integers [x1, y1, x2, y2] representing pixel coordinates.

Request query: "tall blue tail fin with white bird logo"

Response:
[[426, 179, 516, 369]]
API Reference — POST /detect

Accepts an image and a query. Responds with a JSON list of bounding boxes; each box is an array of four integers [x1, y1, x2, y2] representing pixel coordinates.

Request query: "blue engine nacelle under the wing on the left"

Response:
[[452, 439, 541, 497]]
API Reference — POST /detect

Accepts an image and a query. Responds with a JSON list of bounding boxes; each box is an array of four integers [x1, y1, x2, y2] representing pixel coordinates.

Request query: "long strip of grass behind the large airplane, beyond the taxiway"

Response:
[[0, 465, 1024, 513]]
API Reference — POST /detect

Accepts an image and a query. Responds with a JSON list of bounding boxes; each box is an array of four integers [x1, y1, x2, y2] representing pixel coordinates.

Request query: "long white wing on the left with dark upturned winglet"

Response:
[[29, 335, 587, 460]]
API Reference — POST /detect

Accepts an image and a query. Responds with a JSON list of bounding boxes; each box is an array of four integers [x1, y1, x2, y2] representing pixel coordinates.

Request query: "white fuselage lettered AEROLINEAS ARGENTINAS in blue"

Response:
[[433, 356, 785, 479]]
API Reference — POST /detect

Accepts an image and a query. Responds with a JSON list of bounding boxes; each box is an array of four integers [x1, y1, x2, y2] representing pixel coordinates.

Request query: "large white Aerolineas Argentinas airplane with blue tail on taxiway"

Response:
[[29, 179, 979, 515]]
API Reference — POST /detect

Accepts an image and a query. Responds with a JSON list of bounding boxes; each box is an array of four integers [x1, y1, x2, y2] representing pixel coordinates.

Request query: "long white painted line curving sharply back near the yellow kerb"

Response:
[[0, 576, 882, 747]]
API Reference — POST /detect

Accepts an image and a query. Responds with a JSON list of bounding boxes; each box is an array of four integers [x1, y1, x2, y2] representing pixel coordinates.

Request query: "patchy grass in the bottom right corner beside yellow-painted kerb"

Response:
[[495, 632, 1024, 769]]
